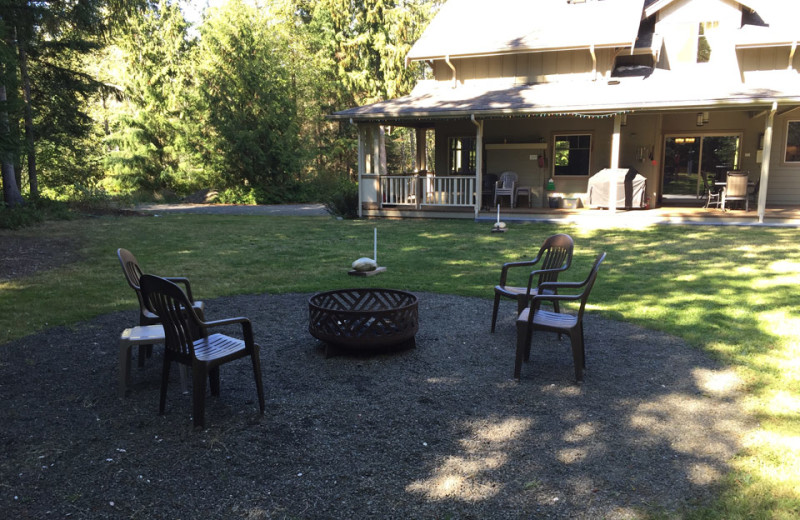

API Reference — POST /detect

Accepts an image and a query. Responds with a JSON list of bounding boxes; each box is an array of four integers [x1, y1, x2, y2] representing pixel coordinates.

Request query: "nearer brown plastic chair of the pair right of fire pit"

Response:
[[514, 253, 606, 381]]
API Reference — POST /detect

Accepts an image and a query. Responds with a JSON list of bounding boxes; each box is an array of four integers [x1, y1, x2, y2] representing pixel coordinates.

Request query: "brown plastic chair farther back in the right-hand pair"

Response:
[[492, 234, 574, 332]]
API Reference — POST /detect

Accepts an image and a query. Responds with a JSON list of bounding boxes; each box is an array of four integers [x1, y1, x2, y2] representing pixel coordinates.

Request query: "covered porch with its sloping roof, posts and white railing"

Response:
[[332, 71, 800, 221]]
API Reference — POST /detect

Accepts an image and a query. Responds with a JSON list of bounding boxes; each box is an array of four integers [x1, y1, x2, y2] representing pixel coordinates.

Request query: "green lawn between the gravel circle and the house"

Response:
[[0, 215, 800, 519]]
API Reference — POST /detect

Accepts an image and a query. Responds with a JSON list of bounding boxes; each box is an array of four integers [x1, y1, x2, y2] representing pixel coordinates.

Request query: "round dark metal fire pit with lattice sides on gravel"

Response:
[[308, 289, 419, 350]]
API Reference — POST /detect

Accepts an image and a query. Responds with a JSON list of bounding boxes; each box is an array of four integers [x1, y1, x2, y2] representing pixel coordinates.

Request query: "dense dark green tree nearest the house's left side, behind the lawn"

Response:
[[194, 0, 300, 198]]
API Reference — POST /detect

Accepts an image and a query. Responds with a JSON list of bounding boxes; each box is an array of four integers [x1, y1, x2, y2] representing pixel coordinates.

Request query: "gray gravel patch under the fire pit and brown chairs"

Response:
[[0, 293, 752, 519]]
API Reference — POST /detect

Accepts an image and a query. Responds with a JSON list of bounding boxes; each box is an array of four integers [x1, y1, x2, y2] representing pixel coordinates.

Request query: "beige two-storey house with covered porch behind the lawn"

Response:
[[330, 0, 800, 219]]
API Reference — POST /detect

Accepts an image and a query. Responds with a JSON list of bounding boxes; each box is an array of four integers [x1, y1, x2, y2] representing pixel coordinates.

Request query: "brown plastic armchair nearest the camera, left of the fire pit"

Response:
[[141, 274, 264, 428]]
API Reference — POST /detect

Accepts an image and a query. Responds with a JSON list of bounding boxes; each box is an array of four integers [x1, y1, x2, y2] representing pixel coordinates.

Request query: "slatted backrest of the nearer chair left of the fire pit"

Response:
[[141, 274, 201, 356]]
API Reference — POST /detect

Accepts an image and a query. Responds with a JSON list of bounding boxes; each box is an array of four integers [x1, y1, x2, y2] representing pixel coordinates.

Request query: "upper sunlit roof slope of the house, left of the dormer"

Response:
[[407, 0, 643, 61]]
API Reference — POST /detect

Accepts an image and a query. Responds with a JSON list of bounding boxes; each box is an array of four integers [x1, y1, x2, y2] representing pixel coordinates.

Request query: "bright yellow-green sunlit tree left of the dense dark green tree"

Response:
[[103, 0, 195, 192]]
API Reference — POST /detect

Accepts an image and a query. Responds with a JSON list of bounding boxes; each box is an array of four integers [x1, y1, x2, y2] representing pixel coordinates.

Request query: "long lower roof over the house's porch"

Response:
[[330, 70, 800, 124]]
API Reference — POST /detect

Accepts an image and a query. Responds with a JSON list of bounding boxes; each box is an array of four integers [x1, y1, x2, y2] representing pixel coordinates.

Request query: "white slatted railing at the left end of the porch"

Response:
[[380, 175, 477, 208]]
